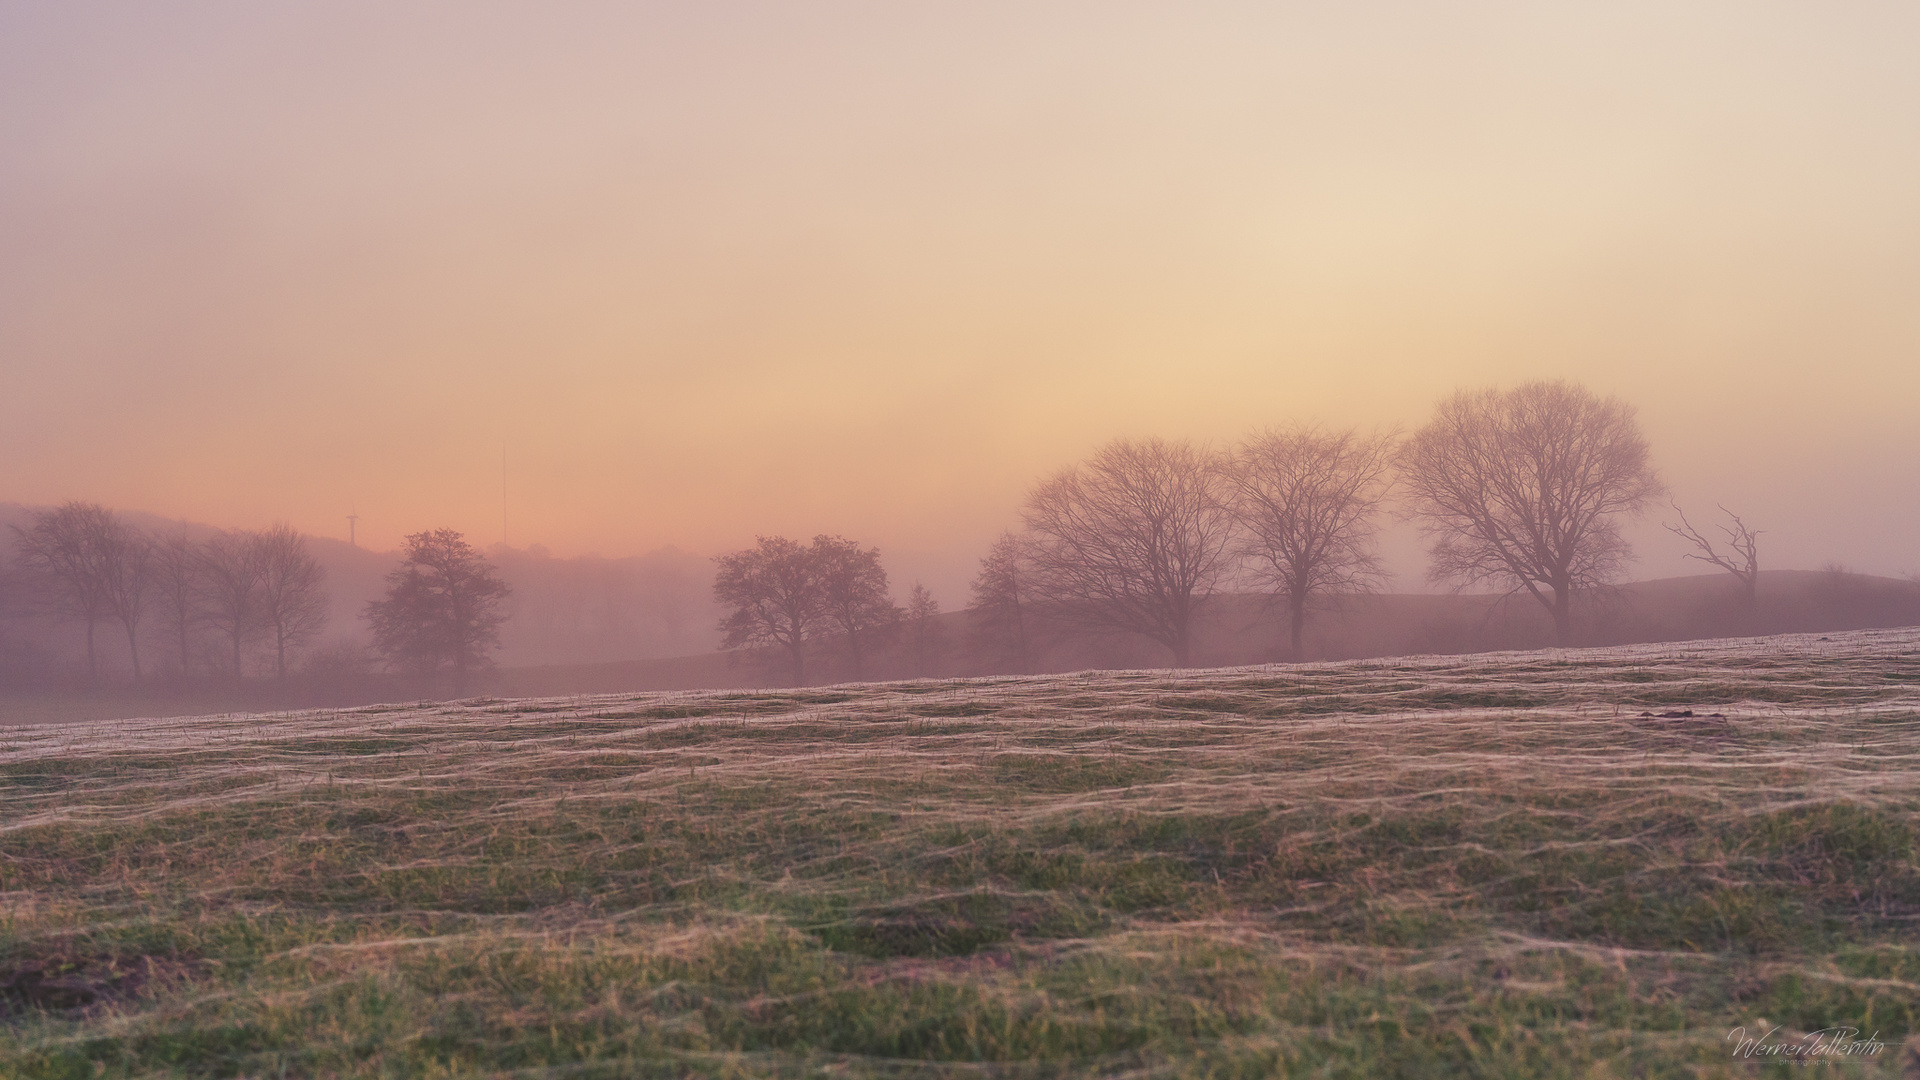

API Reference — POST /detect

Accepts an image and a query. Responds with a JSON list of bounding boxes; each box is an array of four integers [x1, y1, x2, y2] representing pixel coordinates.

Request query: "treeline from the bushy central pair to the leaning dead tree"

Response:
[[714, 382, 1904, 682]]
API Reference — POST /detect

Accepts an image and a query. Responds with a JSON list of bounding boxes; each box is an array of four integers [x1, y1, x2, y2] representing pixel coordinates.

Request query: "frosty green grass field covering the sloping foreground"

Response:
[[0, 630, 1920, 1078]]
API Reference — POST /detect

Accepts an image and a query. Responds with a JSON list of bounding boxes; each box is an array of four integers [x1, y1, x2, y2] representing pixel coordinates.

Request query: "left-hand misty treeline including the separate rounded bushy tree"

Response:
[[0, 502, 509, 688]]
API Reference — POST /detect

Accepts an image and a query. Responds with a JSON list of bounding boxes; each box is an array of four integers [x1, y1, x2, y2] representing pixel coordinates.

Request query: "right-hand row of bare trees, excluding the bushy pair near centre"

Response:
[[973, 382, 1712, 665]]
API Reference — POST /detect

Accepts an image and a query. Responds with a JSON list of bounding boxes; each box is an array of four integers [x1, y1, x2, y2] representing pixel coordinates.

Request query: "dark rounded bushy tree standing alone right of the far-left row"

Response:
[[367, 528, 511, 694]]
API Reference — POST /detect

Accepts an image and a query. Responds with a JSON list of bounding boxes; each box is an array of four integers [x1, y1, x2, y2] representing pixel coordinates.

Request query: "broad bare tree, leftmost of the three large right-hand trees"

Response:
[[1023, 438, 1233, 667]]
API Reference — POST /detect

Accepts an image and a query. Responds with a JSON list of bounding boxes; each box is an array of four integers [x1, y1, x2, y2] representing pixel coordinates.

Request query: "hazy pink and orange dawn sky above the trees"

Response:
[[0, 0, 1920, 607]]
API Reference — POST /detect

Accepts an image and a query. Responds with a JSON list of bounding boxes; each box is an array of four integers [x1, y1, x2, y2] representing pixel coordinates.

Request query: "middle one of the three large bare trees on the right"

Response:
[[1225, 427, 1392, 661]]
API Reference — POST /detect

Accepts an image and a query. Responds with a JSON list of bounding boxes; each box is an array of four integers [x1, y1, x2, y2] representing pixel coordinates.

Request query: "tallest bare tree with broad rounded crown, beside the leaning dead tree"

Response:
[[1398, 382, 1663, 644]]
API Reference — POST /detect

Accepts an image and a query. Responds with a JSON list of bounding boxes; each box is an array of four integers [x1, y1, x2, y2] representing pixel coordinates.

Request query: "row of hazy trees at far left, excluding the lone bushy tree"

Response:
[[13, 502, 326, 680]]
